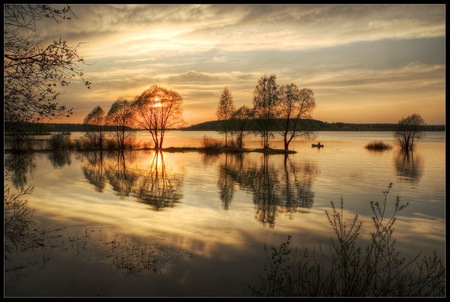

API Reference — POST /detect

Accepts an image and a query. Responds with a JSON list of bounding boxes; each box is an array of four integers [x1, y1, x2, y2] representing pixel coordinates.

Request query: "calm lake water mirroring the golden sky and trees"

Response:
[[5, 131, 446, 297]]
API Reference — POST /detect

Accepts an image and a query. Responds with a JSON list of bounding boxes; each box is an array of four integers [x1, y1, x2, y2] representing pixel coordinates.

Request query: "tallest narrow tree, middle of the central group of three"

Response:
[[253, 75, 279, 148]]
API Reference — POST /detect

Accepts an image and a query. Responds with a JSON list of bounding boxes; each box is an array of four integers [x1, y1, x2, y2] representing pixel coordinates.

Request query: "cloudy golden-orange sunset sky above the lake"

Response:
[[32, 4, 446, 126]]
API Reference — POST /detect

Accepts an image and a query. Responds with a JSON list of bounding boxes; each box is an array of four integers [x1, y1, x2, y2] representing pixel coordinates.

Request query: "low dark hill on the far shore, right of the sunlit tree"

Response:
[[181, 119, 445, 131]]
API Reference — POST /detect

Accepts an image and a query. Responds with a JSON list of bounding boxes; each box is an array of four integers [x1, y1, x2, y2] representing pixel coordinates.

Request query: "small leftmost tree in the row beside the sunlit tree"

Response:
[[84, 106, 106, 149]]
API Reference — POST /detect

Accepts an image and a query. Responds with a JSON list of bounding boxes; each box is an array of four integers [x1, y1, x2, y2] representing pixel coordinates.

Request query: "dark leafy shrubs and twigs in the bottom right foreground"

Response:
[[249, 184, 446, 297]]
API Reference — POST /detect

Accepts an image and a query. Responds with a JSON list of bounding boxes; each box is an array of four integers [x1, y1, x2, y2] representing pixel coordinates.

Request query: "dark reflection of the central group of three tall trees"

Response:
[[217, 153, 318, 227]]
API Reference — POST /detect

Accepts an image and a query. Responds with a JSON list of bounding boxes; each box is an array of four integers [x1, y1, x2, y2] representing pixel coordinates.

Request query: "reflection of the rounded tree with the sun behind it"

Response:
[[135, 151, 183, 211]]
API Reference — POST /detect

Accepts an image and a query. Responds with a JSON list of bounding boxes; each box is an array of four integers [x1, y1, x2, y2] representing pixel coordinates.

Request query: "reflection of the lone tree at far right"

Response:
[[395, 150, 423, 182]]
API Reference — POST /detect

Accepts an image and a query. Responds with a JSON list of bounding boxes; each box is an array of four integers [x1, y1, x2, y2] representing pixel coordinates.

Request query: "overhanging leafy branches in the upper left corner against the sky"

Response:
[[4, 4, 90, 122]]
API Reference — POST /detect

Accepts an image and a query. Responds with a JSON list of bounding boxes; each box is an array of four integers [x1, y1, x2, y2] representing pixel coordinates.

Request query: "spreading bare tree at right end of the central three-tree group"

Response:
[[278, 84, 316, 150]]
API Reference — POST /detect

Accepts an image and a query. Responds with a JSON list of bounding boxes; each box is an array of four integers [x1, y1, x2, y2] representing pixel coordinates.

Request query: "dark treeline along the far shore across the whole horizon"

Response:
[[4, 119, 445, 134]]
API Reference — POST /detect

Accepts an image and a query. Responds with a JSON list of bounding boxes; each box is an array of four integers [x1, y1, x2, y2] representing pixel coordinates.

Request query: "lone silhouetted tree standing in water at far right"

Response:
[[394, 113, 425, 151]]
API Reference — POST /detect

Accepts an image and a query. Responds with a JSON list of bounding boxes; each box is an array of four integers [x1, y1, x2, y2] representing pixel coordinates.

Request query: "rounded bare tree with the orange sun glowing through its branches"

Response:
[[133, 85, 184, 149]]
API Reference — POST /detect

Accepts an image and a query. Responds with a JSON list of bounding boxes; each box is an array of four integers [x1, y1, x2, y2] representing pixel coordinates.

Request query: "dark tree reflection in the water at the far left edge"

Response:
[[5, 152, 36, 189]]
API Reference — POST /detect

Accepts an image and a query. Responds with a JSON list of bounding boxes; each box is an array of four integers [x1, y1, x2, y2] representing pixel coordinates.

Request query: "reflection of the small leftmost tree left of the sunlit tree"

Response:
[[81, 151, 106, 192]]
